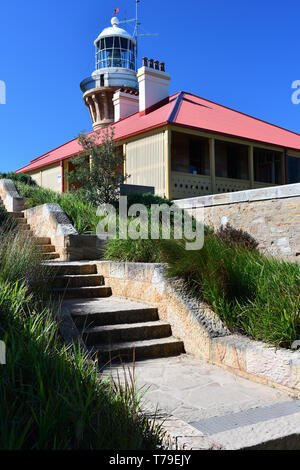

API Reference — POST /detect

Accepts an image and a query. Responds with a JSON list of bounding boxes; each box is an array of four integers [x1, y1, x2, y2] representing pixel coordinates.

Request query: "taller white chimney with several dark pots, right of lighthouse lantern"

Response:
[[137, 57, 170, 113]]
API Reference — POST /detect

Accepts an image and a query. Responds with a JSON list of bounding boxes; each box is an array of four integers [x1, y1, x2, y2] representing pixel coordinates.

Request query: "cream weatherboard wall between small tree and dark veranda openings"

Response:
[[125, 132, 166, 196]]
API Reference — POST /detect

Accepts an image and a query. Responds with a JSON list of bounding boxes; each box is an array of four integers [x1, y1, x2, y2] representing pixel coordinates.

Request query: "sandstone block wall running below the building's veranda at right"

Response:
[[175, 183, 300, 261]]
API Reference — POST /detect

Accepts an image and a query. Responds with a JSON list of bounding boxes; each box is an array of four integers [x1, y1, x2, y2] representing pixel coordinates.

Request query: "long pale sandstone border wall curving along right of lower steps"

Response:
[[97, 261, 300, 394]]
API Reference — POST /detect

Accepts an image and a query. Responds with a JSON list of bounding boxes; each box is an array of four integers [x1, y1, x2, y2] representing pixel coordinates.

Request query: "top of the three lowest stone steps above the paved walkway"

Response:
[[70, 307, 158, 328]]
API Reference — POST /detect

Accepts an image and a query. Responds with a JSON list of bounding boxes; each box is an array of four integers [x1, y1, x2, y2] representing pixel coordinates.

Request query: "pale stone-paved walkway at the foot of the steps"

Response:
[[104, 354, 300, 449]]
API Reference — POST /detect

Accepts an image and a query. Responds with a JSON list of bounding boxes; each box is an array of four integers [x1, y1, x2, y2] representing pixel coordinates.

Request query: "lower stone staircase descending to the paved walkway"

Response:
[[49, 262, 184, 363]]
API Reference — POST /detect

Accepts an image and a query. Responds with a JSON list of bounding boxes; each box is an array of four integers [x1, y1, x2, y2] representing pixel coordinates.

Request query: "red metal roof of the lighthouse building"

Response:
[[17, 92, 300, 173]]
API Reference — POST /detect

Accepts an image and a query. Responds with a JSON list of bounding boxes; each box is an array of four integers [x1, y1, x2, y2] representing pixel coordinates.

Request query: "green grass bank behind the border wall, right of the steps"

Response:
[[105, 231, 300, 348]]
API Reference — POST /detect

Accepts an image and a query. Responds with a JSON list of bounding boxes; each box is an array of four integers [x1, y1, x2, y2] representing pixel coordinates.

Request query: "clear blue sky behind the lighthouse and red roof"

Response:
[[0, 0, 300, 171]]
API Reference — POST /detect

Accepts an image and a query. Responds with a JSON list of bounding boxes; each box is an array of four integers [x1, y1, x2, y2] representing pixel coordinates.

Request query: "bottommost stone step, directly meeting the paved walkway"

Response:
[[90, 336, 184, 363]]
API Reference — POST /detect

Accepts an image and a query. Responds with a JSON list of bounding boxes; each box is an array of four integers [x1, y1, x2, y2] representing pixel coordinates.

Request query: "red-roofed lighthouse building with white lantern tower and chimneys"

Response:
[[17, 18, 300, 199]]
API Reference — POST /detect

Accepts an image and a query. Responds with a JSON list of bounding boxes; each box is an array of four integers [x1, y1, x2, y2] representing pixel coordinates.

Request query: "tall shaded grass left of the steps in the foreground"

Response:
[[0, 227, 160, 450]]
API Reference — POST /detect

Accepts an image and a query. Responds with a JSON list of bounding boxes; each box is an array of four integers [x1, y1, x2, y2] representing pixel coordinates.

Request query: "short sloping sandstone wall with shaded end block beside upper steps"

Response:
[[24, 204, 104, 261]]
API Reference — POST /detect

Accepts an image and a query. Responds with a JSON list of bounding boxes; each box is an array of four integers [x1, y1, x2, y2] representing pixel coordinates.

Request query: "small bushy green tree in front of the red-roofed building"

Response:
[[68, 128, 127, 205]]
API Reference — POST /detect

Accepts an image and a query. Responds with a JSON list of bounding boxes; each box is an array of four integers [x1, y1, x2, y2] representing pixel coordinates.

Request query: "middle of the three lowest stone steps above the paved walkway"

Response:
[[81, 321, 172, 346]]
